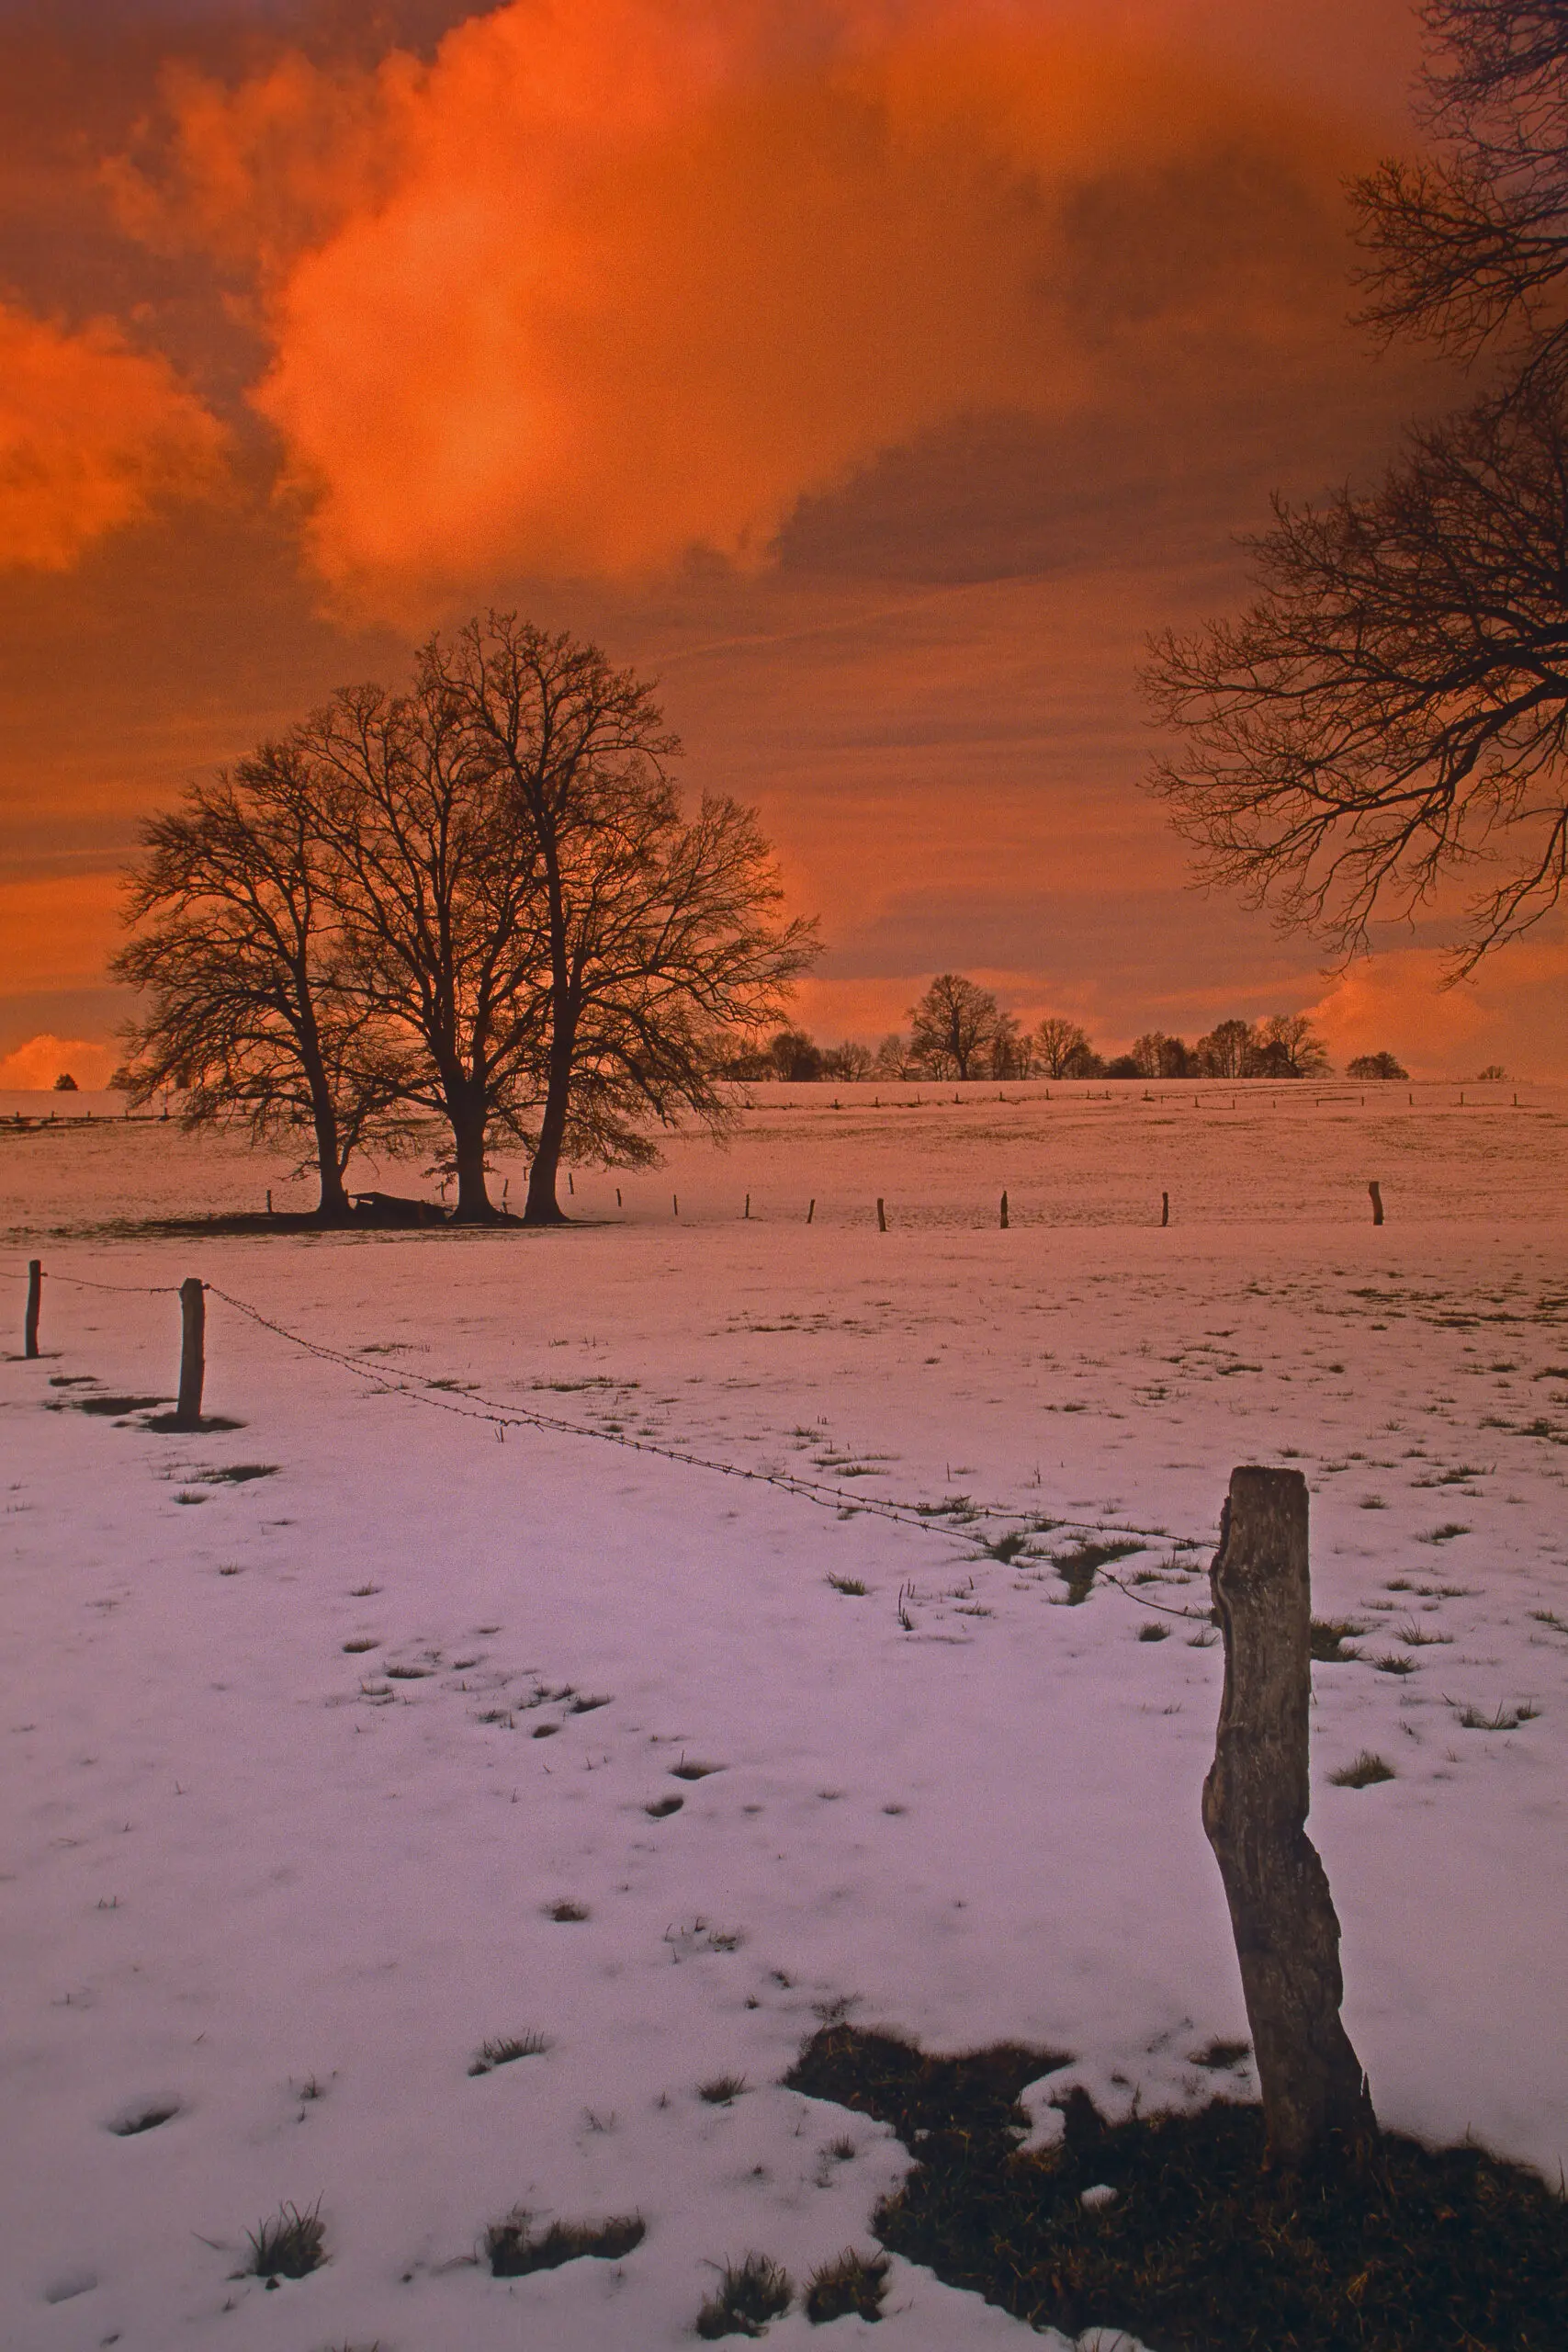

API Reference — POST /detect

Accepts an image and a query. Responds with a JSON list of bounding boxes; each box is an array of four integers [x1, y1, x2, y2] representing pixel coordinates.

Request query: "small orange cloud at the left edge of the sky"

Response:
[[0, 303, 226, 571]]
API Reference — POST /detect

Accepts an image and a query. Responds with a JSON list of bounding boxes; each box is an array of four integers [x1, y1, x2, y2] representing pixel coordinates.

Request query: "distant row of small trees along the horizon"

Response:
[[727, 971, 1405, 1084]]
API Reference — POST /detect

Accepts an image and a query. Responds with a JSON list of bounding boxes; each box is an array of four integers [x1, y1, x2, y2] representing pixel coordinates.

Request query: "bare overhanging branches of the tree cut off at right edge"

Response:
[[1147, 0, 1568, 974]]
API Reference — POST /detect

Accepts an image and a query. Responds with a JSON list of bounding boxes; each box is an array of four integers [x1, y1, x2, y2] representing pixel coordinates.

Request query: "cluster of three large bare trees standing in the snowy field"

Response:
[[113, 614, 816, 1223]]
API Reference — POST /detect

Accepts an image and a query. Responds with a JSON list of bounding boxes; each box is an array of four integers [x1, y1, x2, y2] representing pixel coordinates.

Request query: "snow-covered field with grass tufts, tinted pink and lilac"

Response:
[[0, 1087, 1568, 2352]]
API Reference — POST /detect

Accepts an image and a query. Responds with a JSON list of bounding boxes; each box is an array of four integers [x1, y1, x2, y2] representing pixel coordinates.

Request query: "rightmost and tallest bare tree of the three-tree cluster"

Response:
[[421, 614, 818, 1223]]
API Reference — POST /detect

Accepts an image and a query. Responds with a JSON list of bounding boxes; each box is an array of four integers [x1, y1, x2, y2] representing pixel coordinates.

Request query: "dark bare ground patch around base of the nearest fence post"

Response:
[[787, 2025, 1568, 2352]]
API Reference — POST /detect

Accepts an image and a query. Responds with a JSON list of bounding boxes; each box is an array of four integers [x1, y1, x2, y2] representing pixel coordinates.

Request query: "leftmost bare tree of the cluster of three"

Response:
[[110, 743, 407, 1218]]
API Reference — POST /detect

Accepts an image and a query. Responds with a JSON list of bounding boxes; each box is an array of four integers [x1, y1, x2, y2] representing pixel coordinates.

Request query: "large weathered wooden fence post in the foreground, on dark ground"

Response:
[[1203, 1467, 1378, 2168]]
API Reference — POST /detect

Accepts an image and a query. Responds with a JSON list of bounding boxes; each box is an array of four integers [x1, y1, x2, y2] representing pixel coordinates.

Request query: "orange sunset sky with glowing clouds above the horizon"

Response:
[[0, 0, 1568, 1084]]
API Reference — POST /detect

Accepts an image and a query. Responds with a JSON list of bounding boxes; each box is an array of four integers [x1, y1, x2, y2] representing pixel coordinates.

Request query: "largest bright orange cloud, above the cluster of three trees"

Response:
[[122, 0, 1342, 602]]
